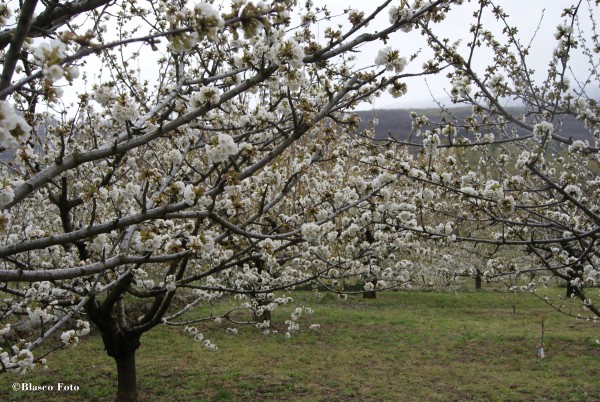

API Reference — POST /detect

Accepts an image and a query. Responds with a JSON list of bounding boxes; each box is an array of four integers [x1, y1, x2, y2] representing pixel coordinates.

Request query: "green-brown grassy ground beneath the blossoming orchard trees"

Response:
[[0, 290, 600, 401]]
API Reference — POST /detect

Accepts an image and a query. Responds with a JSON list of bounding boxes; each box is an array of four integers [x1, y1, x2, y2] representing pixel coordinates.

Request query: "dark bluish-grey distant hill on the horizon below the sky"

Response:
[[355, 108, 593, 143]]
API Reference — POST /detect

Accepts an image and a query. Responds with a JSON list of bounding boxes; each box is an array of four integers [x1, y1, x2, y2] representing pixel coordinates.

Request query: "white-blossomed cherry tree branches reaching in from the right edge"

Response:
[[382, 1, 600, 319]]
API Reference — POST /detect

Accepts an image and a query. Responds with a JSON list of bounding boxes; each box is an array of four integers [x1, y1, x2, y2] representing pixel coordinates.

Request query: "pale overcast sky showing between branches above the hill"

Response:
[[314, 0, 587, 109]]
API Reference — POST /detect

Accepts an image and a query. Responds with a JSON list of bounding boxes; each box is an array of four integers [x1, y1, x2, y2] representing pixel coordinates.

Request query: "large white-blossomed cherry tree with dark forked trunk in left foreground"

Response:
[[0, 0, 461, 400]]
